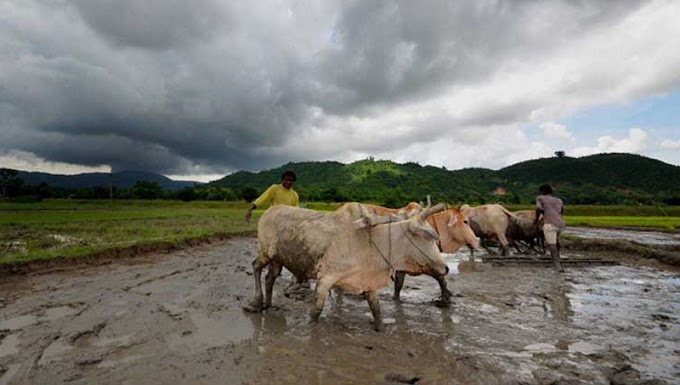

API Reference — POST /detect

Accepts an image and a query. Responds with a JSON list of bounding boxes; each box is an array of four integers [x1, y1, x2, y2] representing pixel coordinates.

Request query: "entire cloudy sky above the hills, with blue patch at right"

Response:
[[0, 0, 680, 181]]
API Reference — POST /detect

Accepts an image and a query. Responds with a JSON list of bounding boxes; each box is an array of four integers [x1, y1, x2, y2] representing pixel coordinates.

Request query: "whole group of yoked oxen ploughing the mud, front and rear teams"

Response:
[[245, 202, 542, 330]]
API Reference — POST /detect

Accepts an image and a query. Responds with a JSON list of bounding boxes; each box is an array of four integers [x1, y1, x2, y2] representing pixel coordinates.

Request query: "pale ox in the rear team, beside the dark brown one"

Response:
[[460, 204, 515, 260]]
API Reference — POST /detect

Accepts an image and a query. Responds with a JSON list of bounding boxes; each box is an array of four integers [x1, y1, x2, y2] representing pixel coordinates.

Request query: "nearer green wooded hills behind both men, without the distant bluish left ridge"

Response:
[[211, 154, 680, 207]]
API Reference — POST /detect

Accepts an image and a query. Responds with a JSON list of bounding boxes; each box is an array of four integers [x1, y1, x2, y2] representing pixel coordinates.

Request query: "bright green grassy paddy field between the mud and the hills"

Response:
[[0, 200, 680, 264]]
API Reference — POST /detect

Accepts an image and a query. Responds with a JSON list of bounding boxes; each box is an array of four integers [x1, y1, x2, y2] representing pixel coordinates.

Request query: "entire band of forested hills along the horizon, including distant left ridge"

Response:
[[6, 154, 680, 207]]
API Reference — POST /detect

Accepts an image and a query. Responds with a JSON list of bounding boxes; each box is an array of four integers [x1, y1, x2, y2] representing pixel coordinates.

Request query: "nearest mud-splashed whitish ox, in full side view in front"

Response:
[[245, 203, 448, 330]]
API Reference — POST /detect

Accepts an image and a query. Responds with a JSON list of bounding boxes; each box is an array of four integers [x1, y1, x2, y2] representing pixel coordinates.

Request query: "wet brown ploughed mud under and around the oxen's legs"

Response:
[[0, 234, 680, 385]]
